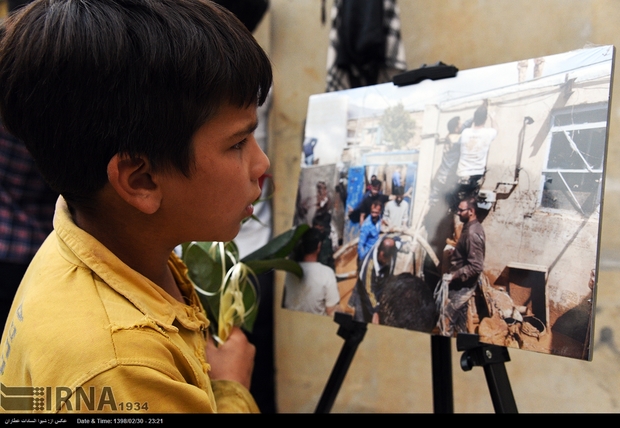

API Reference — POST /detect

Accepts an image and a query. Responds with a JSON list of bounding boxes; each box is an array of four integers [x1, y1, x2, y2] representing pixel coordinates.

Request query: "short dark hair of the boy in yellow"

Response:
[[0, 0, 272, 207]]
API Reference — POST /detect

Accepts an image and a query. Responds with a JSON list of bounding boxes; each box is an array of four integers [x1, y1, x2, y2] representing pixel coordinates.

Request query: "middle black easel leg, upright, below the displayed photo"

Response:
[[431, 336, 454, 413]]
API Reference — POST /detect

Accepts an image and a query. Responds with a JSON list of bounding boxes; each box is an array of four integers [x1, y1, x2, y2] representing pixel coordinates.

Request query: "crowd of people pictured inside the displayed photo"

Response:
[[284, 101, 497, 336]]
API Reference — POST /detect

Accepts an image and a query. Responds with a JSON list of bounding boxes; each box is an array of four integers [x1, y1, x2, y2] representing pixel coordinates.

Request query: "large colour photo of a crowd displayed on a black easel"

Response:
[[282, 46, 614, 359]]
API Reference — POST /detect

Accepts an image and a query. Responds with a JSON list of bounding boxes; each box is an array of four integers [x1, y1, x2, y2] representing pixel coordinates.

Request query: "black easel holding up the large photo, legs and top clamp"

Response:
[[315, 62, 517, 413]]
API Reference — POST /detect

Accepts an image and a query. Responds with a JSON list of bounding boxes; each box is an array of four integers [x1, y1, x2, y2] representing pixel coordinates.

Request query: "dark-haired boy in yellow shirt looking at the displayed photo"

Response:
[[0, 0, 272, 412]]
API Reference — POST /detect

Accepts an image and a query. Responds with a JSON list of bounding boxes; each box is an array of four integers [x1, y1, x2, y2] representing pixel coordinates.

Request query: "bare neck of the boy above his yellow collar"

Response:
[[73, 191, 185, 302]]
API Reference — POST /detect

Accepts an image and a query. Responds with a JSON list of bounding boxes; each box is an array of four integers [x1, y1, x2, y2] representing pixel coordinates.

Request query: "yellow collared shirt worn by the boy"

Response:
[[0, 198, 258, 413]]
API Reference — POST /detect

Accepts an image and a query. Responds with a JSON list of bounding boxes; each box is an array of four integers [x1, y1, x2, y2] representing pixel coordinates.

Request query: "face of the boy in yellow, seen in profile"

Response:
[[162, 105, 269, 242]]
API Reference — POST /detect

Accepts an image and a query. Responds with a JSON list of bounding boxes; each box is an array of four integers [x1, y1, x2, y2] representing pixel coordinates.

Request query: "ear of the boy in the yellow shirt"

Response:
[[108, 153, 162, 214]]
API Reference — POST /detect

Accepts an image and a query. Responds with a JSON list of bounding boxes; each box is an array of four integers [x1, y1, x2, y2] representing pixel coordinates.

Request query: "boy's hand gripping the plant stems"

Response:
[[206, 327, 256, 389]]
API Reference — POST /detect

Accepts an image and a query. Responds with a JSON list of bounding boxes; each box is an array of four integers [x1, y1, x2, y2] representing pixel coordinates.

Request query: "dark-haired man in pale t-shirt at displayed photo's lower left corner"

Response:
[[283, 228, 341, 316]]
